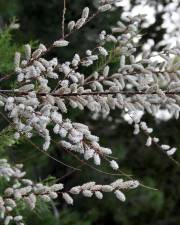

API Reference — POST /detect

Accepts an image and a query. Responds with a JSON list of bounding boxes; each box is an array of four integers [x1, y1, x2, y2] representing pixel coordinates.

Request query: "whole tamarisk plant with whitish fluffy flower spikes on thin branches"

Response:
[[0, 0, 180, 225]]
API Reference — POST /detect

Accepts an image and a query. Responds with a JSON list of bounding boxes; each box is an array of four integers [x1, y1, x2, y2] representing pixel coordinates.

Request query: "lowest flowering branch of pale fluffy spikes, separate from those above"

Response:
[[0, 159, 139, 225]]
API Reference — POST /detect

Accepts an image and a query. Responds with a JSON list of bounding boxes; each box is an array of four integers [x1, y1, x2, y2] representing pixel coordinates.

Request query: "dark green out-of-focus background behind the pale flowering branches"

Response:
[[0, 0, 180, 225]]
